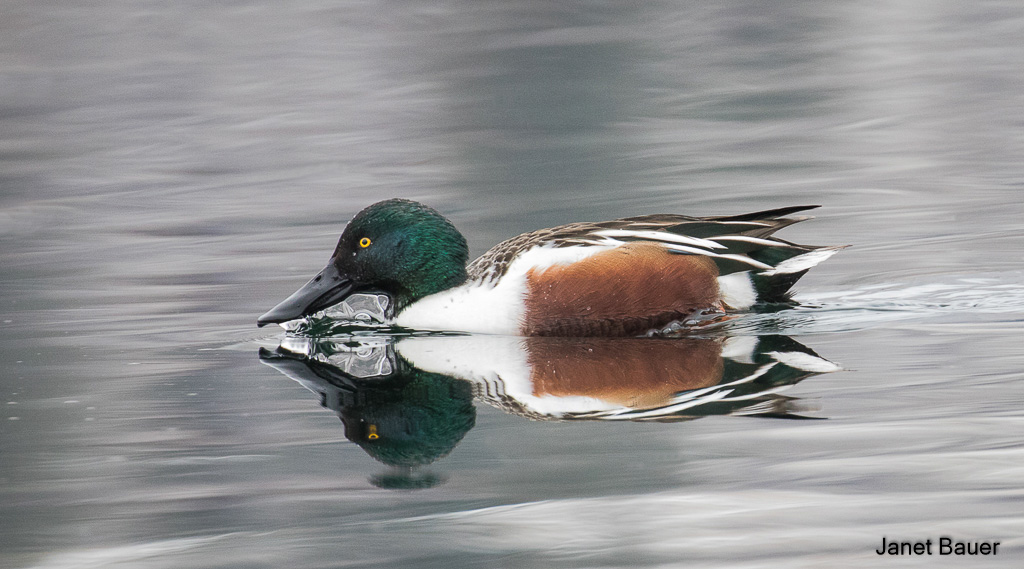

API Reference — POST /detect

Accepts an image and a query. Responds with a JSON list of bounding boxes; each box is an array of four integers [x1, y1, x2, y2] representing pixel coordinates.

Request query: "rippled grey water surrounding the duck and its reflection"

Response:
[[0, 1, 1024, 569]]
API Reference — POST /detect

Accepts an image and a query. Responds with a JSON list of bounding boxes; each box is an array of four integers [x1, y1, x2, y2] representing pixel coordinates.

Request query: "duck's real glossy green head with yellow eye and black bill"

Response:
[[256, 200, 469, 326]]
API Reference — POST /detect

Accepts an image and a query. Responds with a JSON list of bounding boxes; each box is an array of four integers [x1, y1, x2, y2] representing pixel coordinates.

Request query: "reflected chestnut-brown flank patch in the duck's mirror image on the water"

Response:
[[526, 338, 723, 409]]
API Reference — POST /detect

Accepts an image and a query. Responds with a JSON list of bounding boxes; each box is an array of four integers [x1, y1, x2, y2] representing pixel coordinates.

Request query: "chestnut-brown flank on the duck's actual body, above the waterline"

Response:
[[522, 243, 721, 336]]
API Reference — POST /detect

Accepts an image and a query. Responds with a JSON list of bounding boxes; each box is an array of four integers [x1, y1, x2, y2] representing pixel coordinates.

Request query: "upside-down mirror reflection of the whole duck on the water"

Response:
[[260, 336, 839, 488]]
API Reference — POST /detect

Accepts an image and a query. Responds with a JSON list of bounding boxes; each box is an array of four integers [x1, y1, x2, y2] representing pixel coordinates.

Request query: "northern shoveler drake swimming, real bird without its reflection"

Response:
[[257, 200, 841, 336]]
